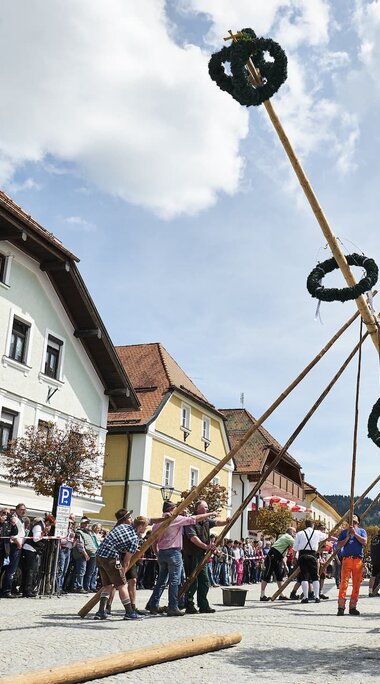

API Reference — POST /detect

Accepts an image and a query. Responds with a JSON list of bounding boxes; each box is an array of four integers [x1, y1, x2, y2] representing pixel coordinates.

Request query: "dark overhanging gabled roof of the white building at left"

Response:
[[0, 190, 139, 409]]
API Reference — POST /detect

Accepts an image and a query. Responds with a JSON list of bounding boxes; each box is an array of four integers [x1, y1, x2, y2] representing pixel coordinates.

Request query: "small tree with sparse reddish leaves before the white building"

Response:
[[3, 423, 103, 515]]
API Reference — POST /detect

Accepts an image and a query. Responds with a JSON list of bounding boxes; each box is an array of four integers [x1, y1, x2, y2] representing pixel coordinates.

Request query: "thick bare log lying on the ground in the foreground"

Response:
[[0, 632, 241, 684]]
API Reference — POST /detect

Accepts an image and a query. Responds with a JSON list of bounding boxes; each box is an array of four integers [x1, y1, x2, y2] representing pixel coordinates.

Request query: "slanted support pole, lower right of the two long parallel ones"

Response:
[[179, 332, 368, 595]]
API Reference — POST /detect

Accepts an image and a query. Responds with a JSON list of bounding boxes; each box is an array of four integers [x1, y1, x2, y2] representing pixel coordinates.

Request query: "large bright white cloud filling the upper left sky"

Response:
[[0, 0, 248, 217]]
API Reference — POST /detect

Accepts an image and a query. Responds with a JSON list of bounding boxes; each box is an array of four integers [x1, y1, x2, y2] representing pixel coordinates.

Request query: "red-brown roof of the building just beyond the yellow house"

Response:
[[219, 409, 300, 473]]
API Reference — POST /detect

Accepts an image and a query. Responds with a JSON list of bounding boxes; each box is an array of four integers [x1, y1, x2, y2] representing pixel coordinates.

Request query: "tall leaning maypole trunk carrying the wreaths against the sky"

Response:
[[243, 52, 380, 352]]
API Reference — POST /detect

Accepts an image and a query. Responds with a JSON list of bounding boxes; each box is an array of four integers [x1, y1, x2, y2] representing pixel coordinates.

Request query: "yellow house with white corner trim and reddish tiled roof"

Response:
[[93, 343, 233, 523]]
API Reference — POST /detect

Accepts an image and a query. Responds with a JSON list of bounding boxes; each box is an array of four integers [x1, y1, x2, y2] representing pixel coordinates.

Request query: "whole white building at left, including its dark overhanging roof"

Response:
[[0, 192, 139, 515]]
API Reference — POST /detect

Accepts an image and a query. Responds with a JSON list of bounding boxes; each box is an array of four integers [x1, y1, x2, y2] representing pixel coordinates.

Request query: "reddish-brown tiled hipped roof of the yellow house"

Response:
[[108, 342, 223, 431]]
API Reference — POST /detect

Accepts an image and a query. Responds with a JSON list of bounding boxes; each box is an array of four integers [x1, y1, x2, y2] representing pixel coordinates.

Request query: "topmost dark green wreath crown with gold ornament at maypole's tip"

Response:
[[208, 28, 288, 107]]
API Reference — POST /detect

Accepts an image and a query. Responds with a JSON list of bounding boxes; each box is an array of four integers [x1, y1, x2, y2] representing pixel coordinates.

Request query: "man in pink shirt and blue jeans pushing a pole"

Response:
[[147, 501, 216, 617]]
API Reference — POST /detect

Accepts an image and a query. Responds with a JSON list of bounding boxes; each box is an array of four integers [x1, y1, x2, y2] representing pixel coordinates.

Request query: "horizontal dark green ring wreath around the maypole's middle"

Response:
[[307, 254, 379, 302]]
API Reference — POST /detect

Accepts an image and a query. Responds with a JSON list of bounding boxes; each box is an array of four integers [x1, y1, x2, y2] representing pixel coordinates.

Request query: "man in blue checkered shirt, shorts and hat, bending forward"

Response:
[[95, 516, 148, 620]]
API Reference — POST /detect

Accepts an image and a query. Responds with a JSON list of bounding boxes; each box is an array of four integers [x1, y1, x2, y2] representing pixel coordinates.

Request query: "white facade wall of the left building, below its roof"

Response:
[[0, 242, 108, 514]]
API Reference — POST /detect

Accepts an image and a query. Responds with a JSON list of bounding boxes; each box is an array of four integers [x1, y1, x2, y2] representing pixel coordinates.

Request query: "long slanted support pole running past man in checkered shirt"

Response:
[[78, 311, 359, 617]]
